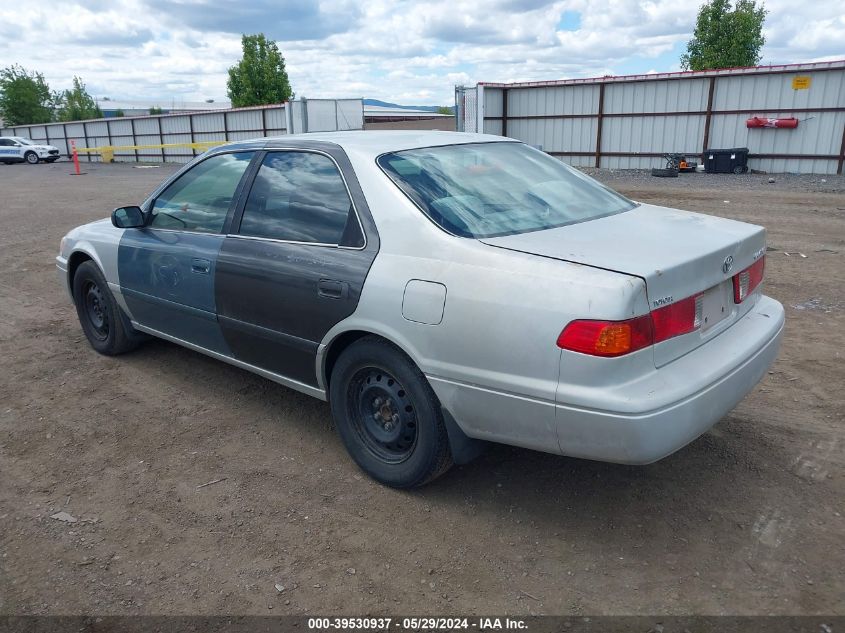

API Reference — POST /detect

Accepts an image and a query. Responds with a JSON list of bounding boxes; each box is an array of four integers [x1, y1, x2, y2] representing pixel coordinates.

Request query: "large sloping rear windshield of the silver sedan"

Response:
[[378, 142, 635, 239]]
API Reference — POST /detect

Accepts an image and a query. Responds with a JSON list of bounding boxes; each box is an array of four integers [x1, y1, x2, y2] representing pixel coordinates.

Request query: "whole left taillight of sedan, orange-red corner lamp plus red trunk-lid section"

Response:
[[557, 294, 704, 356]]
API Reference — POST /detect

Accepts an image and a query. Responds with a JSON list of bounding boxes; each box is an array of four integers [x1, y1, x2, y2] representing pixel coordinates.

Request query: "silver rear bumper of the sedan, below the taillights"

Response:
[[555, 296, 784, 464]]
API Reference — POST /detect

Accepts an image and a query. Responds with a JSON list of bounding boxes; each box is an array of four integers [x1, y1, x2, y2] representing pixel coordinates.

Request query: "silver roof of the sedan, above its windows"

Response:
[[215, 130, 515, 156]]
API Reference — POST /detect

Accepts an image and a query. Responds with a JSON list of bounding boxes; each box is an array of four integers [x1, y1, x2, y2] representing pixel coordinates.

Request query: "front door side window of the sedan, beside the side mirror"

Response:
[[150, 152, 255, 233]]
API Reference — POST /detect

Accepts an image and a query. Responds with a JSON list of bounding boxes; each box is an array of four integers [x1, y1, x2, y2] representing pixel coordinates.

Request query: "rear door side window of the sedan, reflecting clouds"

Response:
[[240, 151, 354, 245]]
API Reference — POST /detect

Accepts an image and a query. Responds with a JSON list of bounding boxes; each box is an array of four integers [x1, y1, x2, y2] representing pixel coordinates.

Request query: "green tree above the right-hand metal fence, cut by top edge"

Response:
[[681, 0, 768, 70]]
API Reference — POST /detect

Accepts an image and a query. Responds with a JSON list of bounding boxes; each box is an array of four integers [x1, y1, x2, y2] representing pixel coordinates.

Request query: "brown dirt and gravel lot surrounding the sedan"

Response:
[[0, 163, 845, 615]]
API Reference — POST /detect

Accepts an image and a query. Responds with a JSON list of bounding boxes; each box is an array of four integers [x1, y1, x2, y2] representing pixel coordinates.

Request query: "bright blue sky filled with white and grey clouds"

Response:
[[0, 0, 845, 106]]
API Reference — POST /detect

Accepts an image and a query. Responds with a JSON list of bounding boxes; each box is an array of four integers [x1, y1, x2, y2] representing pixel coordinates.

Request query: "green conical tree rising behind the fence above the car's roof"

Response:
[[226, 33, 293, 108]]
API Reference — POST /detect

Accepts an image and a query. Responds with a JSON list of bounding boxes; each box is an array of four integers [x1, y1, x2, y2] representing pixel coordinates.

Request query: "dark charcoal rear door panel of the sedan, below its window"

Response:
[[216, 237, 376, 386]]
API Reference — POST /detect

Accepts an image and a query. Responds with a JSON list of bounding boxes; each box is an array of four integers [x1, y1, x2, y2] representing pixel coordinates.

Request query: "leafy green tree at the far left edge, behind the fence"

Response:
[[0, 64, 54, 125]]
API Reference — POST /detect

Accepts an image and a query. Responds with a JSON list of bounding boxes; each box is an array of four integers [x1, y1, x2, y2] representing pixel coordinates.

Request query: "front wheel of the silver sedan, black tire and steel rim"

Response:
[[73, 261, 138, 356]]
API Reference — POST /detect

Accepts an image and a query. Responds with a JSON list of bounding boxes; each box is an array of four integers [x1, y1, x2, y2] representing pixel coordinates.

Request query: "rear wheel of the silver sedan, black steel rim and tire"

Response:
[[329, 336, 452, 488]]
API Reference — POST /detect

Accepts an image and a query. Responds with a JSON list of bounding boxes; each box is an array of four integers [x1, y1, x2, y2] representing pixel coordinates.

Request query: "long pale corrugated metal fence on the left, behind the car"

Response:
[[0, 99, 364, 163]]
